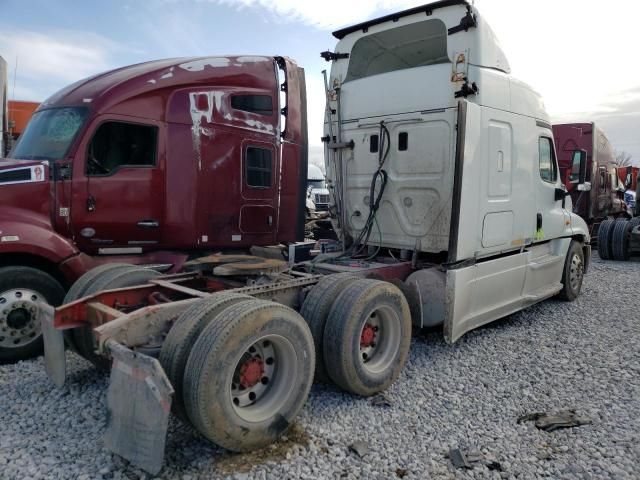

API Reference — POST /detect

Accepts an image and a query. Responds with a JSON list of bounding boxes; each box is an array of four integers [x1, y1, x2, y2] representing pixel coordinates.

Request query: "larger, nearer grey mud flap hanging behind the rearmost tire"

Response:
[[104, 340, 173, 475]]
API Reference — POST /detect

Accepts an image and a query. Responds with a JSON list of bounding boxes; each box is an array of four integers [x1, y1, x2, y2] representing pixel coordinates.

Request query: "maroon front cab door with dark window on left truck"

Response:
[[71, 116, 164, 255]]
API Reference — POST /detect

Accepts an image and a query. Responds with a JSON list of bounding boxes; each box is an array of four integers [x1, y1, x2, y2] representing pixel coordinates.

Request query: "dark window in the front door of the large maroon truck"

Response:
[[87, 122, 158, 175]]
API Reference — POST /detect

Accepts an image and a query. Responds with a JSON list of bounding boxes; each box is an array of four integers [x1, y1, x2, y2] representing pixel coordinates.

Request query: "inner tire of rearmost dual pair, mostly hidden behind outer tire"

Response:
[[158, 292, 253, 420]]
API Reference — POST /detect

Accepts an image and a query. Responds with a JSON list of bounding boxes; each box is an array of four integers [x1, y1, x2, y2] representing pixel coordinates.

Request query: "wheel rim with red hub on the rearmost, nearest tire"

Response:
[[229, 335, 299, 423]]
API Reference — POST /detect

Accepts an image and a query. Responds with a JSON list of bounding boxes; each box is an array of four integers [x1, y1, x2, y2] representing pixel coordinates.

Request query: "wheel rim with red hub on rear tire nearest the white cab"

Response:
[[358, 306, 402, 374]]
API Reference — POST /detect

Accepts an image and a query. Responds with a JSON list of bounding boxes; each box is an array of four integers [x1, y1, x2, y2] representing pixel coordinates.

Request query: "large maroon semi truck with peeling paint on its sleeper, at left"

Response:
[[0, 57, 307, 361]]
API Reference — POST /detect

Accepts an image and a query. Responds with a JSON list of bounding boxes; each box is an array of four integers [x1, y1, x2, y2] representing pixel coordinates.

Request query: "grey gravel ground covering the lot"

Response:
[[0, 253, 640, 480]]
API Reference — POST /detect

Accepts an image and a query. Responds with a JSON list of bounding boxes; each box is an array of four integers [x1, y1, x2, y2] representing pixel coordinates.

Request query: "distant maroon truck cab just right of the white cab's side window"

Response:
[[553, 123, 627, 223]]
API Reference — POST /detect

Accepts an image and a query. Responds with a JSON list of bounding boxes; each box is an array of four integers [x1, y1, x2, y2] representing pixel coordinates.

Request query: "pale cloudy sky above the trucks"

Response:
[[0, 0, 640, 164]]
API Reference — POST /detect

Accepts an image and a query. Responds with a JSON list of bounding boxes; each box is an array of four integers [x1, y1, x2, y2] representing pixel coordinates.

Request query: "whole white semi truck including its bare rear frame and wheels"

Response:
[[37, 0, 591, 474]]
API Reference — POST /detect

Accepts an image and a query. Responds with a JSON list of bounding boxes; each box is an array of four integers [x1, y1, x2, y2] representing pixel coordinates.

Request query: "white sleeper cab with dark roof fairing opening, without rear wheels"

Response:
[[323, 0, 591, 342]]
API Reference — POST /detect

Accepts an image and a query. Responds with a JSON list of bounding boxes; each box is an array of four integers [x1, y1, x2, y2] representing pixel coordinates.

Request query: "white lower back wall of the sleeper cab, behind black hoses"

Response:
[[343, 109, 456, 253]]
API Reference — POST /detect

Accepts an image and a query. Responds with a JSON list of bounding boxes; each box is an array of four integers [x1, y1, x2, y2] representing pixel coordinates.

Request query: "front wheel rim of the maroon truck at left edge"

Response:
[[0, 288, 46, 348]]
